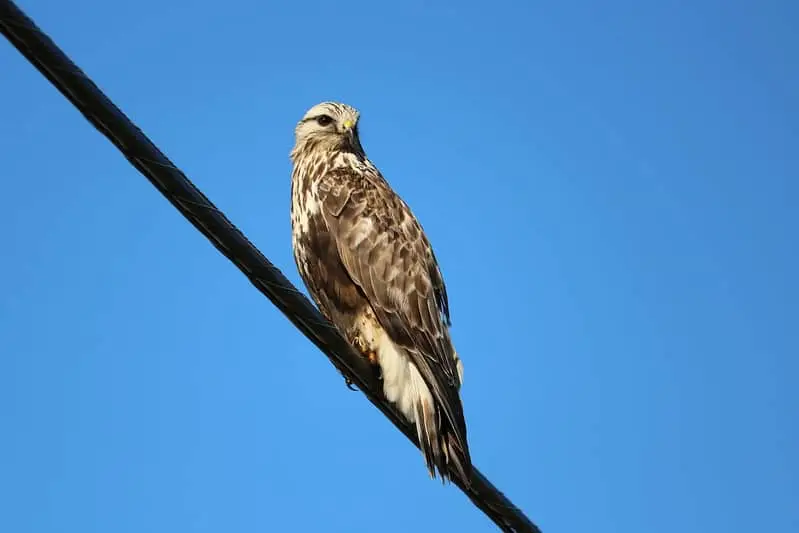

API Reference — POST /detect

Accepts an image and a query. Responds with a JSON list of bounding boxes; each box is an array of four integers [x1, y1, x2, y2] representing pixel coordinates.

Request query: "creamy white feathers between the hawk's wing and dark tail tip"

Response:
[[358, 314, 433, 423]]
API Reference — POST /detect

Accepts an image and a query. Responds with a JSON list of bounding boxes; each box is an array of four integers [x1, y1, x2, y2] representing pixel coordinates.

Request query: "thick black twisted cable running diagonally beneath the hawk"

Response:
[[0, 0, 540, 533]]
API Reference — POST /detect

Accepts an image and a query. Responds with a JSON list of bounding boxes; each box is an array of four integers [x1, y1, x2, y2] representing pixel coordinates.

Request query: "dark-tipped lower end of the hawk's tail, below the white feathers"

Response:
[[415, 399, 472, 488]]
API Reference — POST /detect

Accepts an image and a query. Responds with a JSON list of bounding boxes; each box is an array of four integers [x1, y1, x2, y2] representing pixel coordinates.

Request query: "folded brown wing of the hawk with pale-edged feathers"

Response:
[[318, 169, 468, 457]]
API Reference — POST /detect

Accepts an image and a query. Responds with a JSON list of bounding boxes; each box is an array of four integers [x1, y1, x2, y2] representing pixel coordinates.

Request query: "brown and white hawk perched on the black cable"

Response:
[[291, 102, 471, 485]]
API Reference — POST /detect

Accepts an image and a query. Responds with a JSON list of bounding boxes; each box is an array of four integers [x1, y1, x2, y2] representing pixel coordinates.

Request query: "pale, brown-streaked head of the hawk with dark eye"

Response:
[[291, 102, 364, 159]]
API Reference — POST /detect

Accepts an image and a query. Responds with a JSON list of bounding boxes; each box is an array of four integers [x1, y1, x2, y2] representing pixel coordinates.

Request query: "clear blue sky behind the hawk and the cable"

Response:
[[0, 0, 799, 533]]
